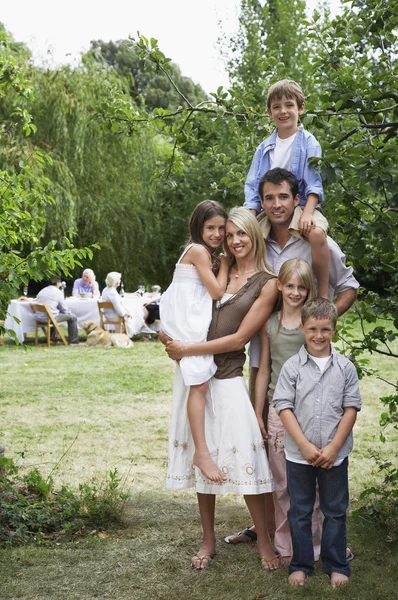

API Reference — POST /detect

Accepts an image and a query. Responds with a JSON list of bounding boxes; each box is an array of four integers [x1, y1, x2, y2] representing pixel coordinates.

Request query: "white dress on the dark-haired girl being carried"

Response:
[[159, 244, 217, 386]]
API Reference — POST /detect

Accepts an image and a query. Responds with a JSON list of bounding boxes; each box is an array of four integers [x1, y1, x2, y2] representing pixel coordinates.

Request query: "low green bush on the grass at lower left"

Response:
[[0, 458, 128, 544]]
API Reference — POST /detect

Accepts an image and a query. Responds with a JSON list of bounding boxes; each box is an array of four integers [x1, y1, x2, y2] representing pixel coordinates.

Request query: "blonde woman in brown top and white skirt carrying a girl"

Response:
[[166, 207, 279, 570]]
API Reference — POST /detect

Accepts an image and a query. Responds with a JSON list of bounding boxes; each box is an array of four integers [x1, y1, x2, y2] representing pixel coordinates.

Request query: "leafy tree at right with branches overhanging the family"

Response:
[[91, 0, 398, 428]]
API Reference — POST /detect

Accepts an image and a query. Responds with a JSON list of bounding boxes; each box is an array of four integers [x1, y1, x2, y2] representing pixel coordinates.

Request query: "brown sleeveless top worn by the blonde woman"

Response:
[[207, 272, 274, 379]]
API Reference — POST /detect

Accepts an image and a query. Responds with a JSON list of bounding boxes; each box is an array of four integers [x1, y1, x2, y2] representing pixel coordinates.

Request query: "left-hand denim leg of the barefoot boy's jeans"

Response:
[[286, 460, 317, 575]]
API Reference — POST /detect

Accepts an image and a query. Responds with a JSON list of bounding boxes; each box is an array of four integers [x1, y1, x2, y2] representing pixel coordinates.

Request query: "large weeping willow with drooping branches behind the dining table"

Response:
[[25, 57, 168, 289]]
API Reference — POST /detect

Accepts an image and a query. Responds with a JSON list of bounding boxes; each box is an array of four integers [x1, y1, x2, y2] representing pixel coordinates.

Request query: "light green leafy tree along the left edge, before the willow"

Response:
[[0, 28, 92, 328]]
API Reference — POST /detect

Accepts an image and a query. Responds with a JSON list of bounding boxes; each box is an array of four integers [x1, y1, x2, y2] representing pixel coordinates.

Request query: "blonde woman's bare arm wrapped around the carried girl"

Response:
[[166, 277, 278, 360]]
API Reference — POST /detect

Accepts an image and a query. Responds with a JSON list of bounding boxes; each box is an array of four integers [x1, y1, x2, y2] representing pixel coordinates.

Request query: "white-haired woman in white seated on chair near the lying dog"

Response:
[[102, 271, 145, 337]]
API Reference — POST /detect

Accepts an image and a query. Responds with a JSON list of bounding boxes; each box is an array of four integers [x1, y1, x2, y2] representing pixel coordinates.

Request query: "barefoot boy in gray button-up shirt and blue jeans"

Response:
[[272, 298, 361, 587]]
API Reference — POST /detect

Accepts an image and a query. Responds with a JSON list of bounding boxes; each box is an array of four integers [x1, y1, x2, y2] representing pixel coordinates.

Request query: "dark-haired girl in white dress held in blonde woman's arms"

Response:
[[160, 200, 229, 483]]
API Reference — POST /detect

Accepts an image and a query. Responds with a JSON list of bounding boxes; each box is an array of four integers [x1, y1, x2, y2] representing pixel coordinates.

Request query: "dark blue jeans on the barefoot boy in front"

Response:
[[286, 458, 351, 577]]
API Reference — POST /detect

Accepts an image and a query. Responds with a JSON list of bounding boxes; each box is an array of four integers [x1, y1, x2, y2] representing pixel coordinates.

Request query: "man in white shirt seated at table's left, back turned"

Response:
[[35, 277, 79, 344]]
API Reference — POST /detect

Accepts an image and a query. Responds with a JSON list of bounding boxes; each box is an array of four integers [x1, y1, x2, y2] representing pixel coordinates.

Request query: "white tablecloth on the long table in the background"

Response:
[[4, 294, 156, 343]]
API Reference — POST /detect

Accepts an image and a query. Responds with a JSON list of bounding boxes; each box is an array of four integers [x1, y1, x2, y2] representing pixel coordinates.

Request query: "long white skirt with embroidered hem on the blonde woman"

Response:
[[166, 366, 274, 494]]
